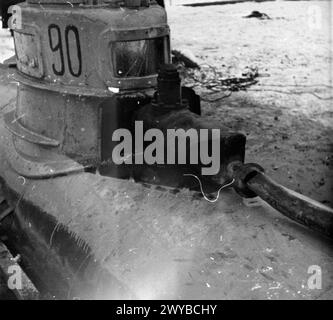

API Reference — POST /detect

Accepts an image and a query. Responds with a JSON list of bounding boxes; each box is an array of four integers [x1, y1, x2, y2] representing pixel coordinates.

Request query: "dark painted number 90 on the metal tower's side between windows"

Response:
[[48, 24, 82, 77]]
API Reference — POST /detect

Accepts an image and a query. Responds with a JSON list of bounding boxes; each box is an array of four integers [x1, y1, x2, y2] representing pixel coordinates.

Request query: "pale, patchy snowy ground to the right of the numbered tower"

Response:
[[168, 1, 333, 205]]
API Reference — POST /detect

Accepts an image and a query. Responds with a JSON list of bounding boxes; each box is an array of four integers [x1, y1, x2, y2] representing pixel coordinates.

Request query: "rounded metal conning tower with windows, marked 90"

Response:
[[5, 0, 170, 178]]
